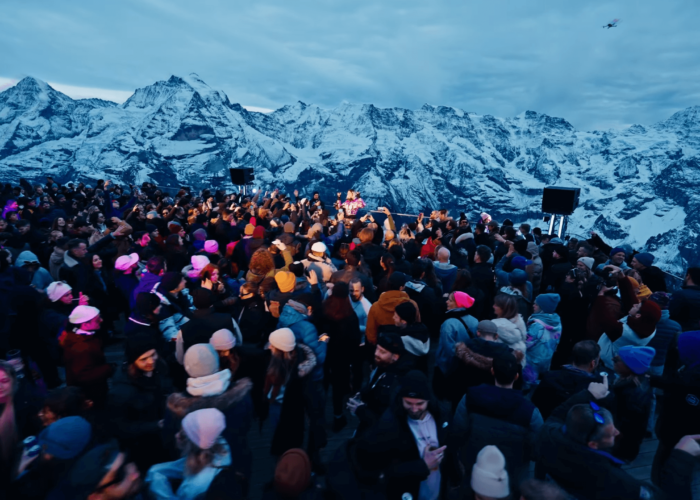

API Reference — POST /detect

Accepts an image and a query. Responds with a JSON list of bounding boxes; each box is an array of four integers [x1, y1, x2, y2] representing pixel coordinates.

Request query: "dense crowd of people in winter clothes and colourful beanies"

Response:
[[0, 178, 700, 500]]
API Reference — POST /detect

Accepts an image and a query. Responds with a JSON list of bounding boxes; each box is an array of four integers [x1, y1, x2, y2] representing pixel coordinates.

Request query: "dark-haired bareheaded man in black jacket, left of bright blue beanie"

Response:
[[532, 340, 603, 420]]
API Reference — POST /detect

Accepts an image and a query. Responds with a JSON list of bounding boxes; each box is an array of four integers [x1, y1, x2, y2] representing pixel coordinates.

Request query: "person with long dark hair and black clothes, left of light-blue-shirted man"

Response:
[[319, 281, 362, 432]]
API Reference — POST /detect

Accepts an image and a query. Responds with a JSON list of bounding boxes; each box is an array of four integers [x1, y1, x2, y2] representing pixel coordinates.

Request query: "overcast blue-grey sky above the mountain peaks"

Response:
[[0, 0, 700, 130]]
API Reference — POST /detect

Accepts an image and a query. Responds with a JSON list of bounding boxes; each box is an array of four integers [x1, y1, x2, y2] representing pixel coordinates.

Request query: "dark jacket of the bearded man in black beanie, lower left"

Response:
[[108, 359, 173, 470]]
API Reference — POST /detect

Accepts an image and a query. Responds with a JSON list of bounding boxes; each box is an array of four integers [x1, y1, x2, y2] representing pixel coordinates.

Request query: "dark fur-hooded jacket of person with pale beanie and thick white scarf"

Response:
[[164, 376, 253, 479]]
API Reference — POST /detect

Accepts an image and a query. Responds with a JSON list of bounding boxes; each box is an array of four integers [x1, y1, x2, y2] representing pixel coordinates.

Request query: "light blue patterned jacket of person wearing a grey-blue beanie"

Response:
[[523, 312, 561, 384]]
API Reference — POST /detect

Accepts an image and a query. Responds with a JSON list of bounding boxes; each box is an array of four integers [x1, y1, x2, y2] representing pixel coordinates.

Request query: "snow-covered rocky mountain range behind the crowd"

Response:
[[0, 74, 700, 271]]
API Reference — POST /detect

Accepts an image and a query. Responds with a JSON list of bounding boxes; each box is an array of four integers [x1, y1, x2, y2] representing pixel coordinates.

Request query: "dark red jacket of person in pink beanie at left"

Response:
[[61, 330, 114, 402]]
